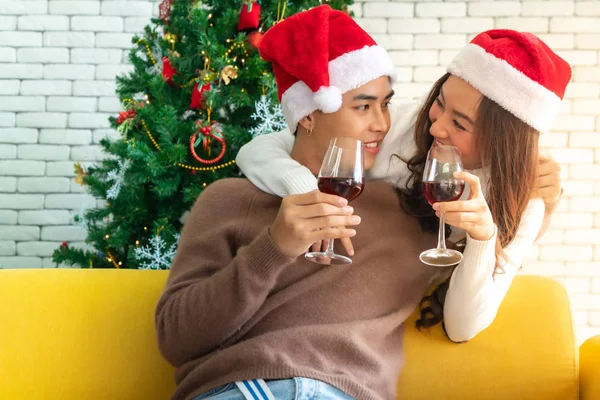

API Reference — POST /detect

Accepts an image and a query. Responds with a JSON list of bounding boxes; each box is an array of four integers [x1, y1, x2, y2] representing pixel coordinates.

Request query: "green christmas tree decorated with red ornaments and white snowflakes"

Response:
[[53, 0, 352, 269]]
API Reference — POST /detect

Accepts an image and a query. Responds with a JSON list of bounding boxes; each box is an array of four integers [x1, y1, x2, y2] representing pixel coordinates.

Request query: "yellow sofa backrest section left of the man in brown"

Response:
[[0, 269, 175, 400]]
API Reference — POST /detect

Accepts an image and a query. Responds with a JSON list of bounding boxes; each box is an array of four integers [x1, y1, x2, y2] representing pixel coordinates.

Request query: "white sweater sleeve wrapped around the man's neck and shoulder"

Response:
[[236, 129, 317, 197]]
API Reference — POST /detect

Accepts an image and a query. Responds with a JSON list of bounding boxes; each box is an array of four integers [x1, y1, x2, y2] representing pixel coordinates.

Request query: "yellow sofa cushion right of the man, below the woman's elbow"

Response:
[[398, 276, 578, 400]]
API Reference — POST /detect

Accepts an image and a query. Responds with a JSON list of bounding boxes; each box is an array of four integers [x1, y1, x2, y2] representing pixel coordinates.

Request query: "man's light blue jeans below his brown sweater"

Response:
[[193, 378, 354, 400]]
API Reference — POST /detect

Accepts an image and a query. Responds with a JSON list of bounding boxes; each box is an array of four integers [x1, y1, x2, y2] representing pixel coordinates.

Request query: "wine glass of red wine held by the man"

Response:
[[305, 137, 365, 265]]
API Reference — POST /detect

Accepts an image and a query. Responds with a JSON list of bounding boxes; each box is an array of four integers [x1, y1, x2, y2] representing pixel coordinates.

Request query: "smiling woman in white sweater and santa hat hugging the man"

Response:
[[237, 30, 571, 342]]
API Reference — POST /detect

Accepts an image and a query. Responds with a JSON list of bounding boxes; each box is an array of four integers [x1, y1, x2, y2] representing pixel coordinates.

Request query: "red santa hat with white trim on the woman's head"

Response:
[[448, 29, 571, 133]]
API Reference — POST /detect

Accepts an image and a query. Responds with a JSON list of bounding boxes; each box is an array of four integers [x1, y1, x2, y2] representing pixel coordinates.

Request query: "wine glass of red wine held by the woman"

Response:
[[419, 144, 465, 267]]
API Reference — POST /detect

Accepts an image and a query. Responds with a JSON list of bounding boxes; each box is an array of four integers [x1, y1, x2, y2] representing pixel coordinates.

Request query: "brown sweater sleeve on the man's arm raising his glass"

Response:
[[155, 179, 295, 366]]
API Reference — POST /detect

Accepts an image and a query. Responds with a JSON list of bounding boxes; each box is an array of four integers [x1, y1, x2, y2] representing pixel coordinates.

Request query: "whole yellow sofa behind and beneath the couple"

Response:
[[0, 269, 600, 400]]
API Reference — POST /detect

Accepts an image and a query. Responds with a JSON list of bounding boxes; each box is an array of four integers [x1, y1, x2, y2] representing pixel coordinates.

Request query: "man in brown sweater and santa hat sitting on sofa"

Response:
[[156, 6, 446, 400]]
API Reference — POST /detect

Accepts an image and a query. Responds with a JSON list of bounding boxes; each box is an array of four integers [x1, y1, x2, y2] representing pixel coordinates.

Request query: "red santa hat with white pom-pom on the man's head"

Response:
[[259, 5, 396, 132]]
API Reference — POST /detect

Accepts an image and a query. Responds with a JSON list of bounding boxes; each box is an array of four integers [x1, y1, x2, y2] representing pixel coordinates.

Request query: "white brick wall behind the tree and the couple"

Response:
[[0, 0, 600, 340]]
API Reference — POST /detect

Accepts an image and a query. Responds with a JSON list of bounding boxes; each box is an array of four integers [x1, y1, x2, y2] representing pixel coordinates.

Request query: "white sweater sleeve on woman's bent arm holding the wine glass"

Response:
[[444, 199, 545, 342]]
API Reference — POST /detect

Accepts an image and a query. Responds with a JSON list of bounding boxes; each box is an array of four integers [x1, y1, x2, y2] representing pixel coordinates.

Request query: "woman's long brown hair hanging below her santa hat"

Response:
[[401, 74, 539, 329]]
